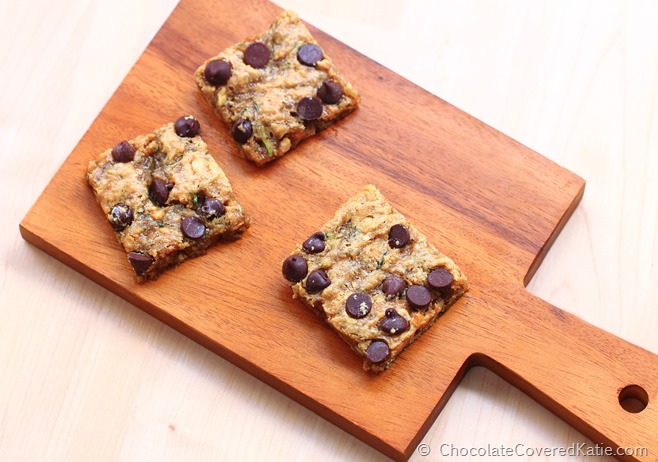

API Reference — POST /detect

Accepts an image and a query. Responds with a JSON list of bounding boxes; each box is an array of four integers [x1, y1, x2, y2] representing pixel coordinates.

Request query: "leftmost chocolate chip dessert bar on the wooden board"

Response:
[[86, 116, 249, 282]]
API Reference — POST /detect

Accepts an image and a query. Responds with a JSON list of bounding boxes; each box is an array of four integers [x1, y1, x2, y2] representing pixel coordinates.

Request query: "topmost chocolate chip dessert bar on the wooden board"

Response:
[[194, 11, 359, 165]]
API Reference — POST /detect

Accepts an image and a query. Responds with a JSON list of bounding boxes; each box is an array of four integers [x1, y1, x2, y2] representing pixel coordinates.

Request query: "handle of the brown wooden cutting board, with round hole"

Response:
[[471, 289, 658, 462]]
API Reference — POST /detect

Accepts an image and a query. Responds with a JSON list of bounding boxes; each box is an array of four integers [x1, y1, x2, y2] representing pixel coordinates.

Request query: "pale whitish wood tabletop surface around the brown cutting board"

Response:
[[0, 0, 658, 461]]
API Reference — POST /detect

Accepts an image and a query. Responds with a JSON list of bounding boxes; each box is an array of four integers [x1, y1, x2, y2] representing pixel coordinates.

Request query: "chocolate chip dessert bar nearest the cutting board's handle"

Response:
[[282, 185, 468, 372]]
